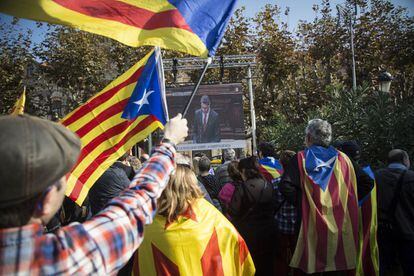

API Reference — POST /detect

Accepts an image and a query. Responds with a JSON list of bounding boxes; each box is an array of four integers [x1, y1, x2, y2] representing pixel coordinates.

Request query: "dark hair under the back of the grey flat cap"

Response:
[[0, 193, 44, 229]]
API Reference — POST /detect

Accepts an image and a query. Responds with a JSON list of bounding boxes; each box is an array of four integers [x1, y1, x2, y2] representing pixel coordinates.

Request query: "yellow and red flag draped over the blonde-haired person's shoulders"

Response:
[[133, 199, 255, 276]]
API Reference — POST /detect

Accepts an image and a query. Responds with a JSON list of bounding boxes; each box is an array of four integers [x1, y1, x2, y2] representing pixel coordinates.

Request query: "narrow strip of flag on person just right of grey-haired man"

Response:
[[356, 166, 379, 276]]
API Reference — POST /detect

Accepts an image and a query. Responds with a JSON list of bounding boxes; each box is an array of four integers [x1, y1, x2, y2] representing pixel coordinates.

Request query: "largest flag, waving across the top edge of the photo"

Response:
[[0, 0, 237, 56]]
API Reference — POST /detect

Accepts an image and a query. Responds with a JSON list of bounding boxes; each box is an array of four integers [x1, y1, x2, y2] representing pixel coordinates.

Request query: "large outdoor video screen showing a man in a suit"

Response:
[[167, 83, 246, 151]]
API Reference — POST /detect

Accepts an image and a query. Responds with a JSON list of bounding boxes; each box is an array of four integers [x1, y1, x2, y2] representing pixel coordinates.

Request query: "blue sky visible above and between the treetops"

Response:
[[0, 0, 414, 43]]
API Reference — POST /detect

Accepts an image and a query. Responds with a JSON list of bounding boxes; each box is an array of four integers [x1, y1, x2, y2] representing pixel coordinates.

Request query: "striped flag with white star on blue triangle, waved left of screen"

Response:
[[61, 48, 168, 205]]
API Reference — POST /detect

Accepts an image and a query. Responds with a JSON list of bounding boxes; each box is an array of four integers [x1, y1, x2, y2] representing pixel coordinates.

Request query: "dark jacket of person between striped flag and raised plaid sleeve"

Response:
[[89, 162, 134, 215]]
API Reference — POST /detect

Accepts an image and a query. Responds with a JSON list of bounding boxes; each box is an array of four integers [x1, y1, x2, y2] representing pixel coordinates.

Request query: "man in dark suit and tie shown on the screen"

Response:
[[193, 95, 220, 143]]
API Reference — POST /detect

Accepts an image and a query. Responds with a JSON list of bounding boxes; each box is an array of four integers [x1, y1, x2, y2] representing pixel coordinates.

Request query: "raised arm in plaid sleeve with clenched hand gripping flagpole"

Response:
[[57, 115, 188, 274]]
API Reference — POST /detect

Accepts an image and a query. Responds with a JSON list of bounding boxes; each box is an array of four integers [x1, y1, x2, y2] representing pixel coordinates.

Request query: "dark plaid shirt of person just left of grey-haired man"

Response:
[[274, 178, 297, 235]]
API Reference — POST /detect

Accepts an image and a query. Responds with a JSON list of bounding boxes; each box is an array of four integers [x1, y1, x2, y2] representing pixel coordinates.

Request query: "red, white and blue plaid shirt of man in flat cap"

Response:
[[0, 143, 175, 275]]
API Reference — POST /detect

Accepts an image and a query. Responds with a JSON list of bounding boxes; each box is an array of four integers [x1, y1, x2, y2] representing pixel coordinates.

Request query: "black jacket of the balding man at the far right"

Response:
[[375, 168, 414, 240]]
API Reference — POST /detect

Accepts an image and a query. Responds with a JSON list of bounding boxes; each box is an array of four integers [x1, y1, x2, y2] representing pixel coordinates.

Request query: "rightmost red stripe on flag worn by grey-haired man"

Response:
[[338, 154, 358, 248]]
